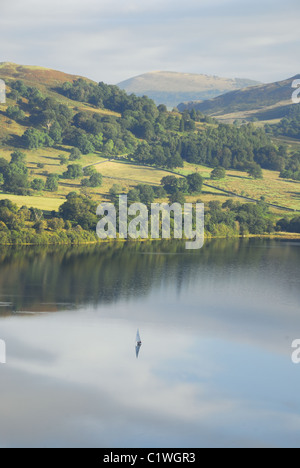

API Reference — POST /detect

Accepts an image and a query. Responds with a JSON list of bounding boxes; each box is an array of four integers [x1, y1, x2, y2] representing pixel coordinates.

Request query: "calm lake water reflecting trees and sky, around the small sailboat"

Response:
[[0, 240, 300, 448]]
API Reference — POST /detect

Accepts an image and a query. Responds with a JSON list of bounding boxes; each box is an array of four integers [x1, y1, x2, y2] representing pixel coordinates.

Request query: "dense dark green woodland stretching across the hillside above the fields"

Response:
[[7, 79, 294, 171]]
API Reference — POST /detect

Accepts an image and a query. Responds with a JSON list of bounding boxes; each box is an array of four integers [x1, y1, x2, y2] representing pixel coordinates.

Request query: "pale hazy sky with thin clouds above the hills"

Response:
[[0, 0, 300, 83]]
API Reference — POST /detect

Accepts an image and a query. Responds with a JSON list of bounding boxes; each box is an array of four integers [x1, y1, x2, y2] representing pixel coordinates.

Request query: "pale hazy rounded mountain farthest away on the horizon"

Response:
[[118, 71, 258, 107]]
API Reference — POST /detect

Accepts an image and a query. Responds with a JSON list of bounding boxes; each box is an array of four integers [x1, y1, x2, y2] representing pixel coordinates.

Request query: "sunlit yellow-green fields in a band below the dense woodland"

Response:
[[0, 153, 300, 211]]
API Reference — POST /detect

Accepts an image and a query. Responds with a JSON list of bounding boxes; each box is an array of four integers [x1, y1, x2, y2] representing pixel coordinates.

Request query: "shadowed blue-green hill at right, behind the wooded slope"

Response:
[[178, 75, 300, 120]]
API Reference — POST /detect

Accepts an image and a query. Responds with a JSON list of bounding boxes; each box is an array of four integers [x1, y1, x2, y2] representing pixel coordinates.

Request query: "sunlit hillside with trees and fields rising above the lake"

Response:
[[0, 63, 300, 243]]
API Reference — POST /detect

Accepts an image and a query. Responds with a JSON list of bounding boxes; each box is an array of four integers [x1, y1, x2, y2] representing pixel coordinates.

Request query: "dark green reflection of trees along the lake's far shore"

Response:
[[0, 239, 299, 313]]
